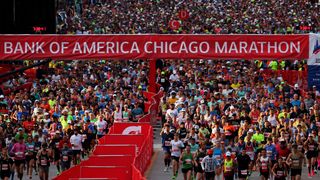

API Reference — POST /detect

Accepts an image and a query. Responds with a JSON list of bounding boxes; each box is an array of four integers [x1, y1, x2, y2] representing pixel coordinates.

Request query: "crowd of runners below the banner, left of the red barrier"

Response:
[[0, 60, 148, 179]]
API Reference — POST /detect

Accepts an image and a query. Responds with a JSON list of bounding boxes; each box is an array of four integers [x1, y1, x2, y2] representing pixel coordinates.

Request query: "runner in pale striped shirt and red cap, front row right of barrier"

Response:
[[201, 149, 220, 180]]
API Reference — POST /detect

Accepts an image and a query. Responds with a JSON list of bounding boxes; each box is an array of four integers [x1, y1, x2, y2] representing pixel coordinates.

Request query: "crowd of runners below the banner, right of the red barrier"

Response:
[[158, 60, 320, 180]]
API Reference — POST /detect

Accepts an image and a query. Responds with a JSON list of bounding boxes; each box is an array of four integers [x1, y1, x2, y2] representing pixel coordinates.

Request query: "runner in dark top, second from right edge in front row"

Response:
[[286, 144, 306, 180]]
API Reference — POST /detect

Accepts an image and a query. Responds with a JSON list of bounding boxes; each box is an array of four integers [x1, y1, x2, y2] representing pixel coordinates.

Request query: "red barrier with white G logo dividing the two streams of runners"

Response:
[[54, 91, 162, 180]]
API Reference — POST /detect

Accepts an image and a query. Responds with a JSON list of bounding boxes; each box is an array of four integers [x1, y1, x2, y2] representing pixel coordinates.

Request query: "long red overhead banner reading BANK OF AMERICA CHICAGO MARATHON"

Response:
[[0, 34, 309, 60]]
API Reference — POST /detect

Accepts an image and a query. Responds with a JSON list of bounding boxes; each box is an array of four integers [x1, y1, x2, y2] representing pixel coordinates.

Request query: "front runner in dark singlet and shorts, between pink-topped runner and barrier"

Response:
[[37, 143, 52, 180]]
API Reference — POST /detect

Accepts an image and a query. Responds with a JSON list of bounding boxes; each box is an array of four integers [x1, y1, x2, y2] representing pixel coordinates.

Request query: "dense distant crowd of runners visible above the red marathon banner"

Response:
[[57, 0, 320, 34]]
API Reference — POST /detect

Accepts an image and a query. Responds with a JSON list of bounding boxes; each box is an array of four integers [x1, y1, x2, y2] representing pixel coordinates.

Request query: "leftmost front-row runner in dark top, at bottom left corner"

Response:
[[0, 147, 13, 180]]
